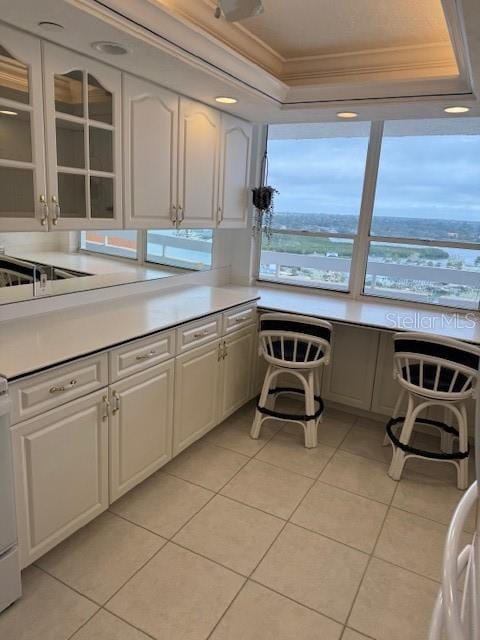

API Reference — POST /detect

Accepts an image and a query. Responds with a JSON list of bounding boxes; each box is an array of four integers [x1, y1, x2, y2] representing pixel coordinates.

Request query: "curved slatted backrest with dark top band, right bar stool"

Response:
[[394, 332, 480, 399]]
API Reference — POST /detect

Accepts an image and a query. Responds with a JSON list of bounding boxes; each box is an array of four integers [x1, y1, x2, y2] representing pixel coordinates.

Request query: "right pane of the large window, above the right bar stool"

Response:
[[364, 118, 480, 308]]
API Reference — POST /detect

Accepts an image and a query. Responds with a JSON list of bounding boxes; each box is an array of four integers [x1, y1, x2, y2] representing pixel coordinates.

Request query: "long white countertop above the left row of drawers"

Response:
[[0, 285, 258, 379]]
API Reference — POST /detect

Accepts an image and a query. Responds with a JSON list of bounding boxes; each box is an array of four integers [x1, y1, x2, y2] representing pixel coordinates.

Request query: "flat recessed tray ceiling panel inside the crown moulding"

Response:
[[240, 0, 450, 58]]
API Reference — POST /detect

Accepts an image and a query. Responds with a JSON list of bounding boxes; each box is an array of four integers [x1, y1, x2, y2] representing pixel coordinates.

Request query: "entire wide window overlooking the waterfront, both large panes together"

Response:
[[259, 117, 480, 309]]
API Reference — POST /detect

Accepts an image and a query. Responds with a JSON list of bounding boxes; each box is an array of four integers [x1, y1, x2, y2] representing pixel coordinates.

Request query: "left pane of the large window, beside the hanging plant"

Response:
[[259, 122, 370, 291]]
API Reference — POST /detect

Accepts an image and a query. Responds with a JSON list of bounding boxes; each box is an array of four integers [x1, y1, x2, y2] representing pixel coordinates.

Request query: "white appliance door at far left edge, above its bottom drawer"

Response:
[[0, 379, 17, 555]]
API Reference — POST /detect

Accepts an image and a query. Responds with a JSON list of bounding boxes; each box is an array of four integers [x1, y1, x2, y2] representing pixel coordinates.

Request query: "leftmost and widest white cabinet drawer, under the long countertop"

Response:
[[9, 353, 108, 424]]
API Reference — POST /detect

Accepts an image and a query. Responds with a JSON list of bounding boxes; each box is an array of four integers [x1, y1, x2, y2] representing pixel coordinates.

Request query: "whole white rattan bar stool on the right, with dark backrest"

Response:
[[384, 333, 480, 489]]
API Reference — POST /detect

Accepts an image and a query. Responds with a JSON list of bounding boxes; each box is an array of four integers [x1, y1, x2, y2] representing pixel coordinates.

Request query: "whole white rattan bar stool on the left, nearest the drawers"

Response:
[[250, 313, 332, 448]]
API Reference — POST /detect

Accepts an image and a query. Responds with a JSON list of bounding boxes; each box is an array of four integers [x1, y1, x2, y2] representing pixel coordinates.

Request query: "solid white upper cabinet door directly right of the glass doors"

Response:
[[123, 75, 179, 229]]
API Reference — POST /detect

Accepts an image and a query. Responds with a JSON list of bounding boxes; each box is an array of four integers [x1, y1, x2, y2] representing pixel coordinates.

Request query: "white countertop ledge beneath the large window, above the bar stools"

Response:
[[251, 286, 480, 344]]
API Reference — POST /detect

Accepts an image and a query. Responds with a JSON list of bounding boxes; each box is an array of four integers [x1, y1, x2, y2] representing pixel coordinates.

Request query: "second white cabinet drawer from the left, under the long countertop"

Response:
[[109, 330, 175, 382]]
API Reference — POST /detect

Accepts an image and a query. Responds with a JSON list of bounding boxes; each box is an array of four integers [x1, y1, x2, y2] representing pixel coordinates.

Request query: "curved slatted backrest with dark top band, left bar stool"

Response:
[[260, 313, 333, 369]]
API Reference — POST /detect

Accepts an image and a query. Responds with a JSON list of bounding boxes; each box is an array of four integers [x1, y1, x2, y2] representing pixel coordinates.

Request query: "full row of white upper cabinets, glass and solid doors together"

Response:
[[0, 25, 252, 231]]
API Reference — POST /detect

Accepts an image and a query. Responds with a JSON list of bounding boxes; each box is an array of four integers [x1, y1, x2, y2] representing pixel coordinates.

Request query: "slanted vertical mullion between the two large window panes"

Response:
[[350, 121, 383, 298]]
